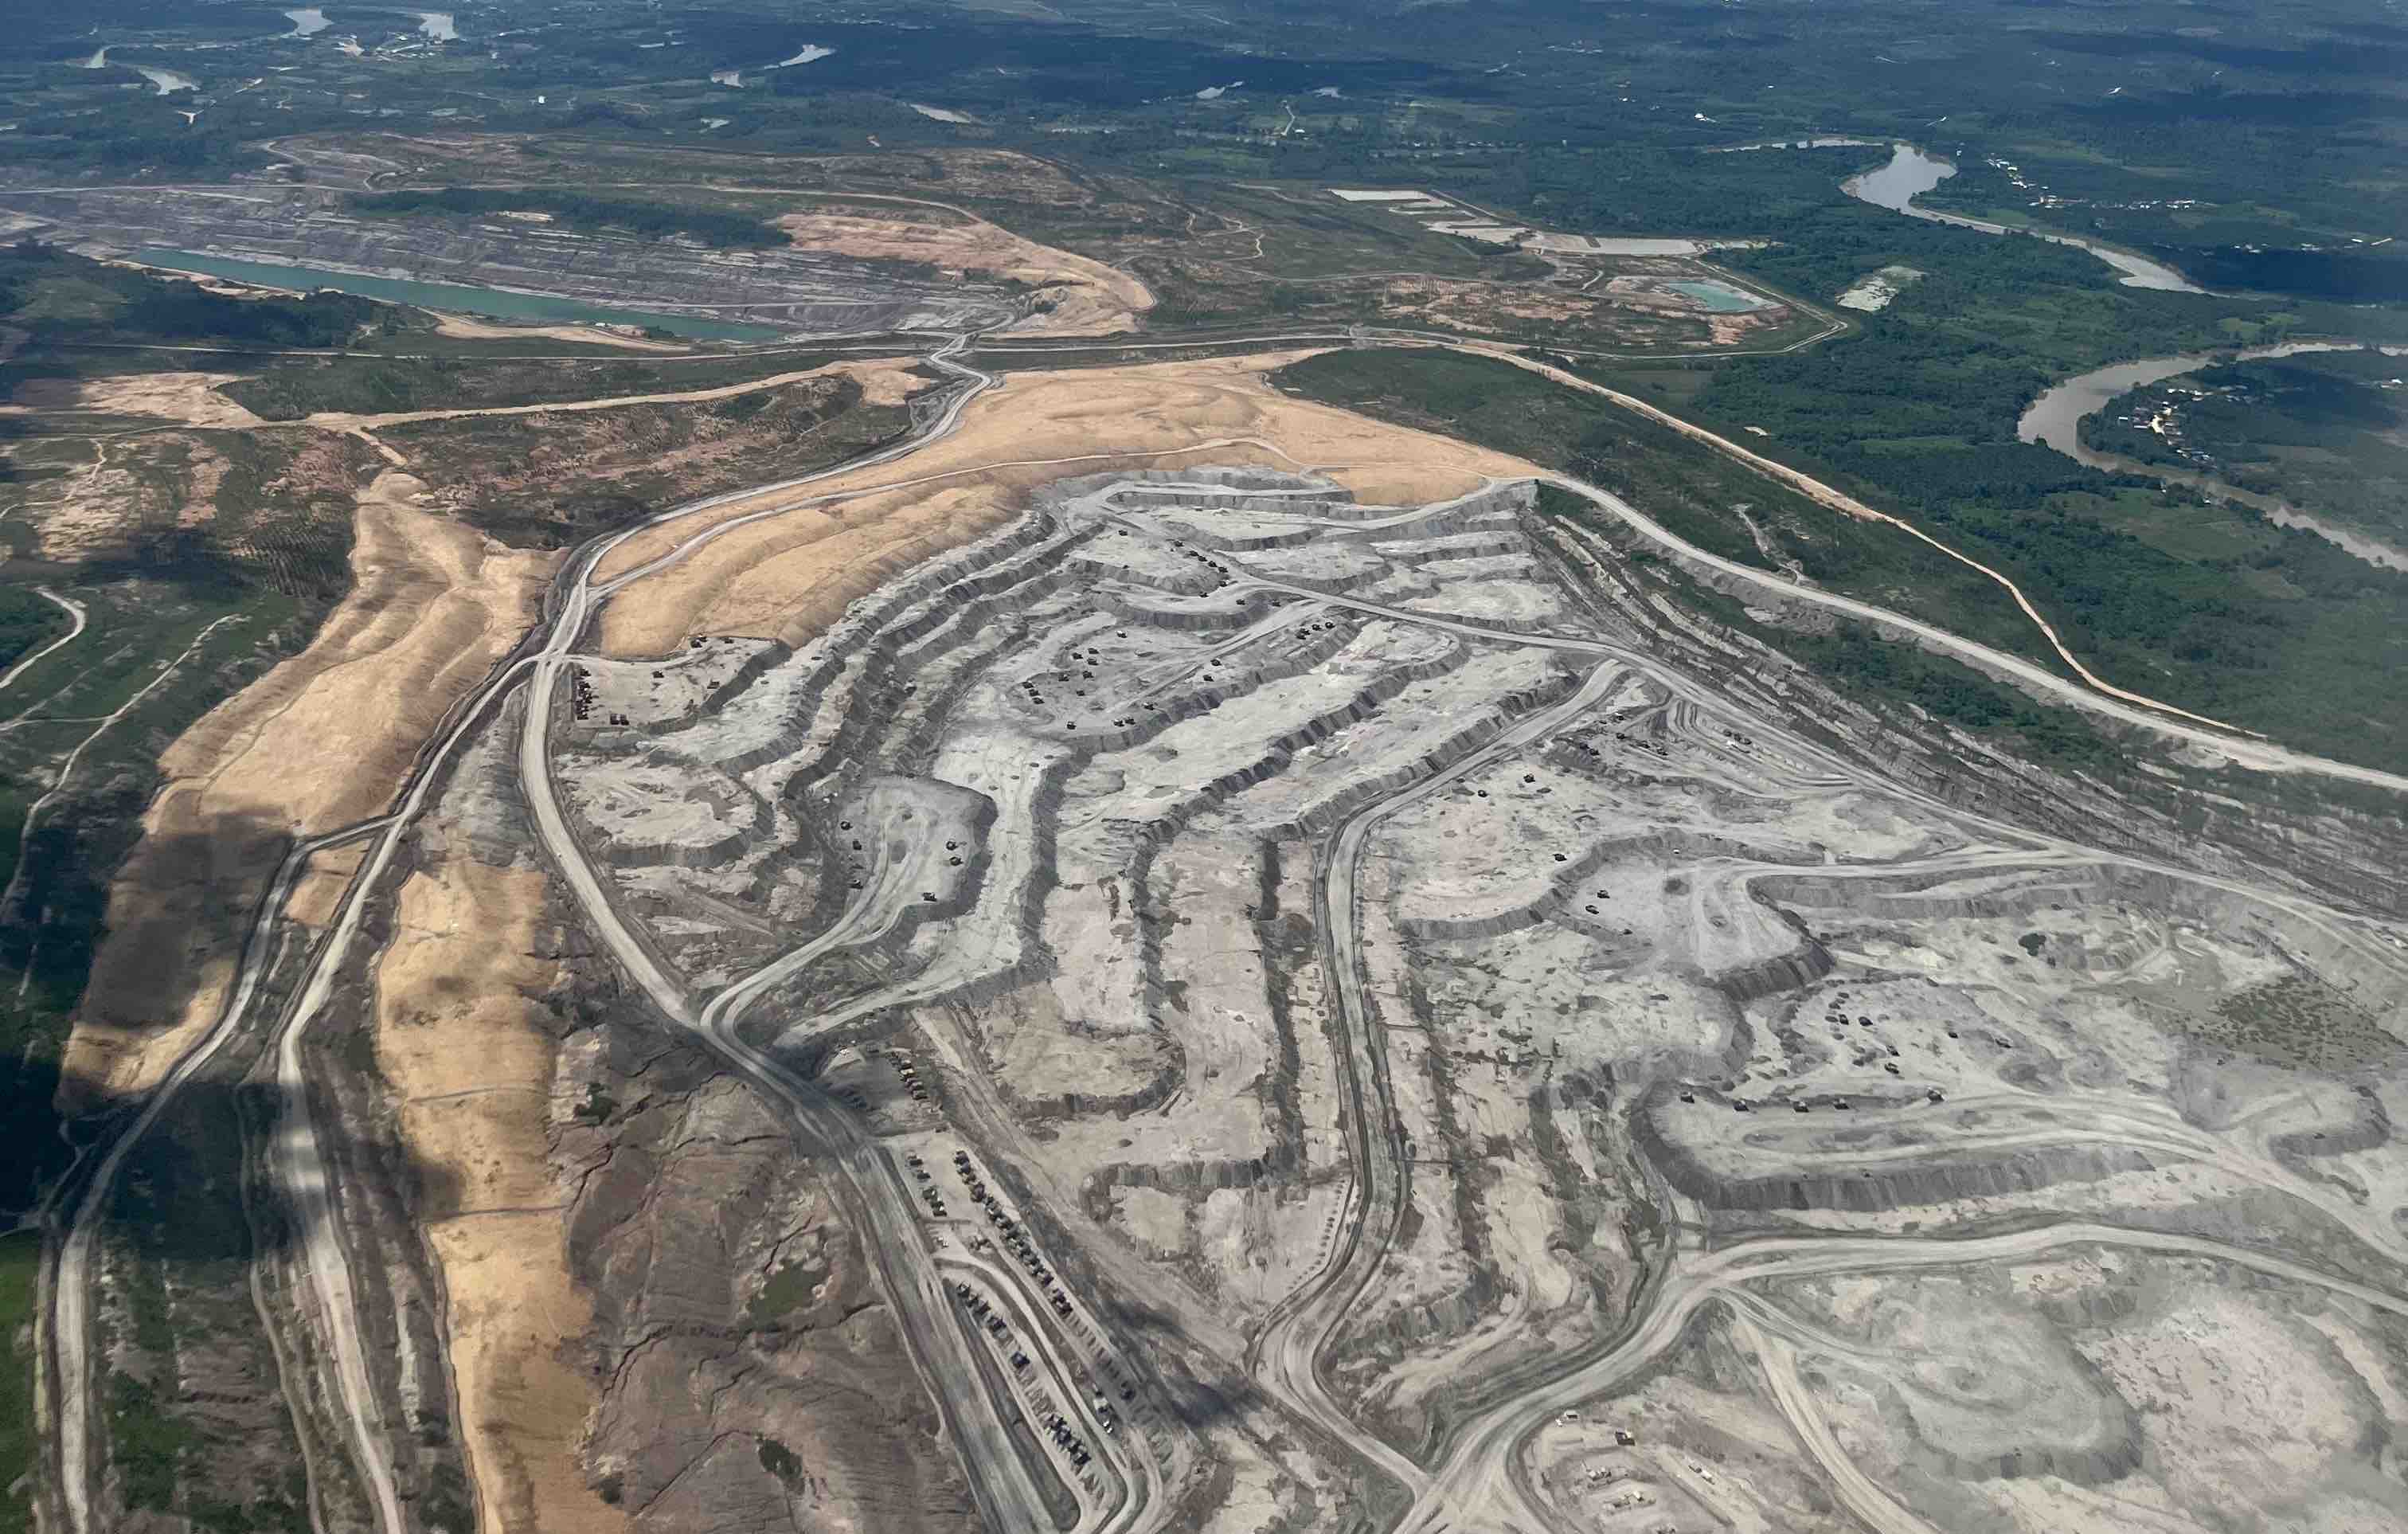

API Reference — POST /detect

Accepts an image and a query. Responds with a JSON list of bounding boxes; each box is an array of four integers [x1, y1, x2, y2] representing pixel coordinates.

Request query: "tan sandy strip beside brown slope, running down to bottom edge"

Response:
[[376, 857, 626, 1534]]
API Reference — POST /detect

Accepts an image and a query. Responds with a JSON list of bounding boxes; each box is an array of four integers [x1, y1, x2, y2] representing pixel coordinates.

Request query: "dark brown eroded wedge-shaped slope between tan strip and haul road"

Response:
[[416, 701, 978, 1534]]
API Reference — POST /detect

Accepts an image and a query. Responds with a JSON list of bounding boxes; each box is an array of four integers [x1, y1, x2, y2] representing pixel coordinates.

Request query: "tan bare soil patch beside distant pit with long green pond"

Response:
[[778, 207, 1153, 335]]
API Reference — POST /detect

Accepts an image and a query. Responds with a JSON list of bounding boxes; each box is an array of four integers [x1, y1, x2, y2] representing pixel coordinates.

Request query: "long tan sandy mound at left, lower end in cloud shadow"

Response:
[[65, 475, 554, 1094]]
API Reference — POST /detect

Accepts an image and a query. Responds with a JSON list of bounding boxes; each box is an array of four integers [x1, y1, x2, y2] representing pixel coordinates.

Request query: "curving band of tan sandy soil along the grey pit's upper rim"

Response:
[[602, 351, 1534, 655]]
